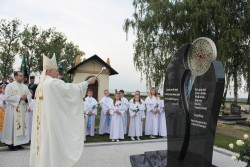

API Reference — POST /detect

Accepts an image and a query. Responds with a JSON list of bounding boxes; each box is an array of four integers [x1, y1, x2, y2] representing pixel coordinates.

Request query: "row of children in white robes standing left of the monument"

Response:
[[84, 88, 167, 142]]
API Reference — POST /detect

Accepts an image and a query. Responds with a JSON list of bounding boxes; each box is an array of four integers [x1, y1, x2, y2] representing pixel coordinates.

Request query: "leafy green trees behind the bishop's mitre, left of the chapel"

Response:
[[21, 25, 84, 82]]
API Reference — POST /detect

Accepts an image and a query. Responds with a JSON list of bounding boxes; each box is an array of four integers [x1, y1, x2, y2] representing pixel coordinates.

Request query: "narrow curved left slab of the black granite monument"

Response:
[[164, 44, 190, 159]]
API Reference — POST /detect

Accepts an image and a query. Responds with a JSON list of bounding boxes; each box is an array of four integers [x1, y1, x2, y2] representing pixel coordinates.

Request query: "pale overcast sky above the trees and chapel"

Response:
[[0, 0, 246, 97]]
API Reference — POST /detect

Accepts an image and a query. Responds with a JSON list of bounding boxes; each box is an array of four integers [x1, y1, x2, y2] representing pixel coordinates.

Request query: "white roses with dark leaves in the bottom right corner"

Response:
[[229, 134, 250, 167]]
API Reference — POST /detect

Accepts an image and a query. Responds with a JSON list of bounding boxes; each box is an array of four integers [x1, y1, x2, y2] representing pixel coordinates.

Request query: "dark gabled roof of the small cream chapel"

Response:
[[68, 55, 118, 75]]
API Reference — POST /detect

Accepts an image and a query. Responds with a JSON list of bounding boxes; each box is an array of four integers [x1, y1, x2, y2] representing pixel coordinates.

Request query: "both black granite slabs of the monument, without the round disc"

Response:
[[164, 41, 225, 167]]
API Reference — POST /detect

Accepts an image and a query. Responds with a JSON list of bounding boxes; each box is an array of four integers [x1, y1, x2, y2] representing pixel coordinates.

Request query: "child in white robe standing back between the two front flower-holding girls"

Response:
[[119, 90, 129, 134]]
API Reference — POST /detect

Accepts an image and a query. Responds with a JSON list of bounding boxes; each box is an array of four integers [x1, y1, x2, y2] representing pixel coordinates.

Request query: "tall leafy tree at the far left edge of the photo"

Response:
[[0, 19, 21, 77]]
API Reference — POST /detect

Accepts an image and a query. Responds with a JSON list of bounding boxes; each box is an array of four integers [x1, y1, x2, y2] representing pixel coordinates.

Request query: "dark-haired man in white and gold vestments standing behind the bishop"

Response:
[[2, 71, 31, 151]]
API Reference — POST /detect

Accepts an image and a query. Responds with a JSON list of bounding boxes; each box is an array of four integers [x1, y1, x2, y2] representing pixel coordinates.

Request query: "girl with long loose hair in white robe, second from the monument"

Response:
[[145, 87, 160, 138]]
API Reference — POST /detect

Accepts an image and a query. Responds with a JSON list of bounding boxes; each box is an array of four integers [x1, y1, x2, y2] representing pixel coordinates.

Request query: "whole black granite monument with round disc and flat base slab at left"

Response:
[[130, 37, 225, 167]]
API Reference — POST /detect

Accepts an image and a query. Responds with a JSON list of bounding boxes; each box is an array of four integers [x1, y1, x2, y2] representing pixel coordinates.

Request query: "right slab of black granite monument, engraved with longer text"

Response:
[[184, 61, 225, 167]]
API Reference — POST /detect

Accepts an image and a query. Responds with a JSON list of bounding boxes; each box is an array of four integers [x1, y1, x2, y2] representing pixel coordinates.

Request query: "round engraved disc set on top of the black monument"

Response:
[[187, 37, 217, 76]]
